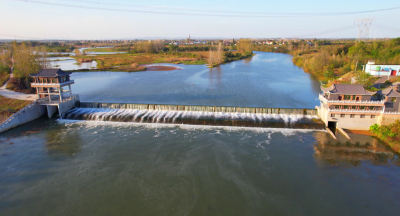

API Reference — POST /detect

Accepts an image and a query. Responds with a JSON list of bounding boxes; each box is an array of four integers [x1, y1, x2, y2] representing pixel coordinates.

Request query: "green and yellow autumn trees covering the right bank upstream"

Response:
[[253, 38, 400, 82]]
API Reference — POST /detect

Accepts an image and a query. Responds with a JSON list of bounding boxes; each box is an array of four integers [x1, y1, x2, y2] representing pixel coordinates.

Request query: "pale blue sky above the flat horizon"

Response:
[[0, 0, 400, 40]]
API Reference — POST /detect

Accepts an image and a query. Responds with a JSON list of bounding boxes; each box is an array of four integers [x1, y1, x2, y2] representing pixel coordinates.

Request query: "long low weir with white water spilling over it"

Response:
[[62, 103, 325, 129]]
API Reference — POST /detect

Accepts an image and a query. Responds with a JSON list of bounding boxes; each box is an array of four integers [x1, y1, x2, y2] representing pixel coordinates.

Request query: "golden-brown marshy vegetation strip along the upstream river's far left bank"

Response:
[[74, 39, 253, 72]]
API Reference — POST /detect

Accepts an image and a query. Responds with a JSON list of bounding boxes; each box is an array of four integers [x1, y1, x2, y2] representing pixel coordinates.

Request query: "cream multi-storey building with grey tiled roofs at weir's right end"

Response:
[[316, 84, 400, 130]]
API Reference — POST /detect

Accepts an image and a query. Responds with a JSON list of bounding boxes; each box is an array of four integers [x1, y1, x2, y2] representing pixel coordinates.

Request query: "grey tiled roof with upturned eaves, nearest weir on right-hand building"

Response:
[[321, 84, 376, 95]]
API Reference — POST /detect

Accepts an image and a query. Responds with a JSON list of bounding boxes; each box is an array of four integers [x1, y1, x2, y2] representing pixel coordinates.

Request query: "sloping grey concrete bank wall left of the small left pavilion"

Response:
[[0, 103, 47, 132]]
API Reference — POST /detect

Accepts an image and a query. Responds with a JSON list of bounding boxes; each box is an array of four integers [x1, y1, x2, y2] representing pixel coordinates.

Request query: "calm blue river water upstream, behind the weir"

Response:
[[71, 52, 320, 108]]
